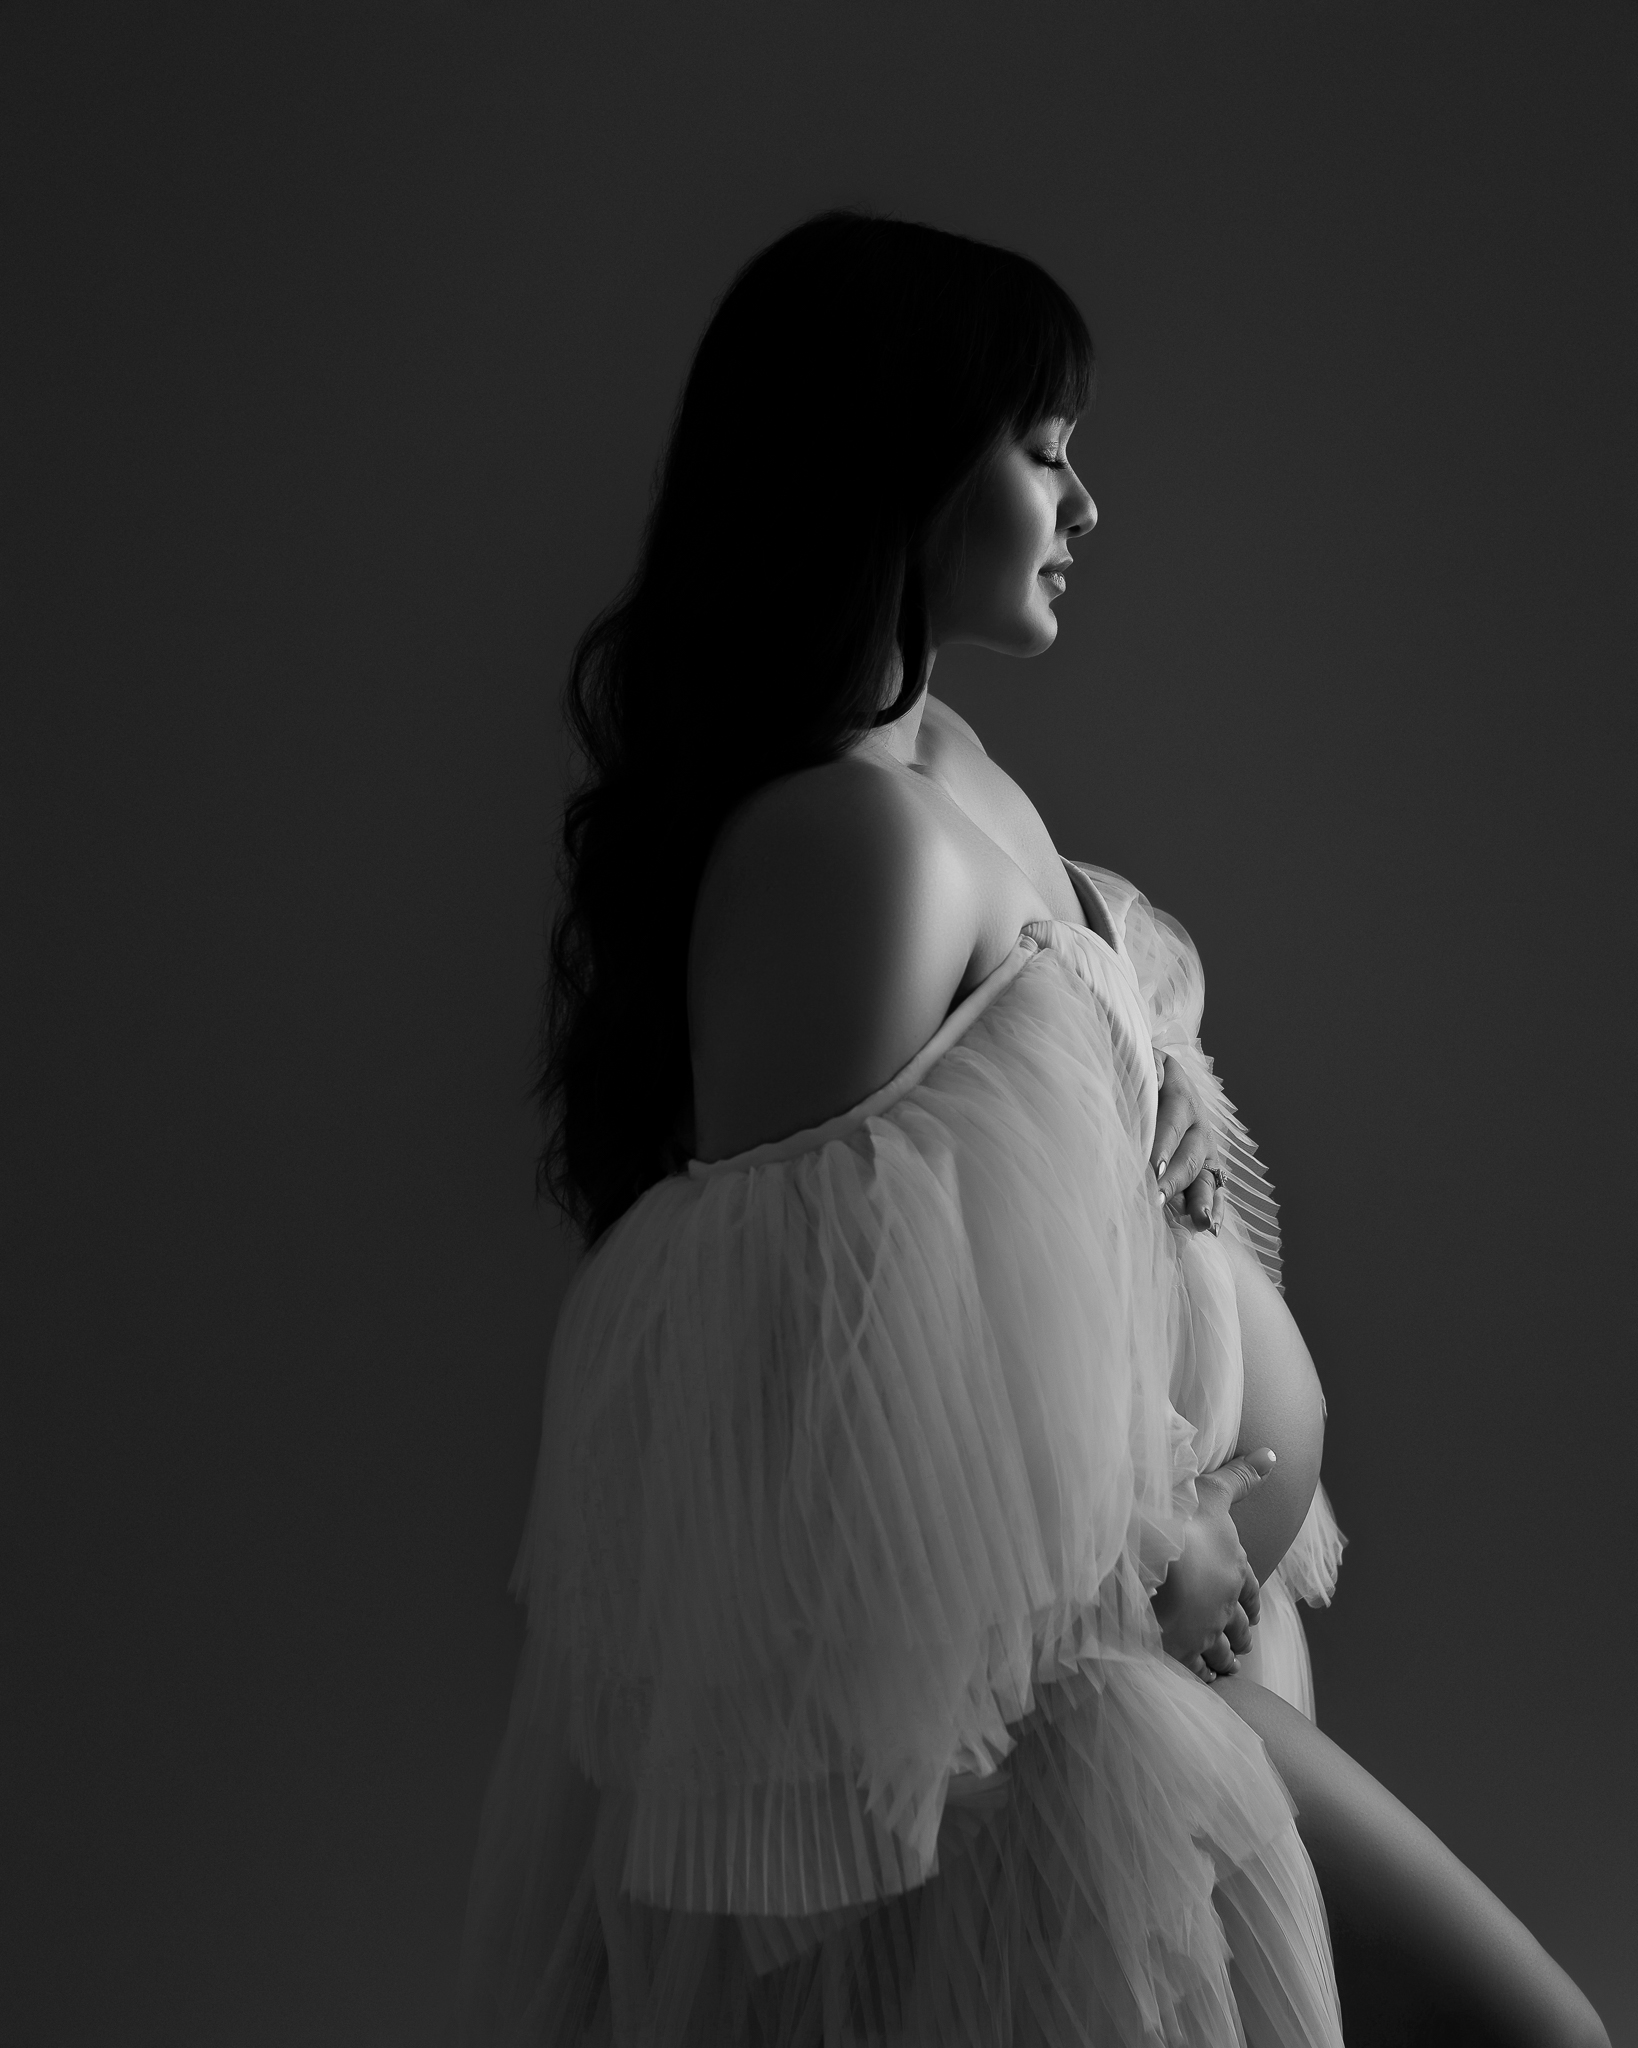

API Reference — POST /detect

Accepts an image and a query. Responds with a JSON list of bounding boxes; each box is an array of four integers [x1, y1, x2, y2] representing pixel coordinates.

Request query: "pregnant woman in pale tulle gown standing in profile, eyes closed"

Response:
[[465, 215, 1605, 2048]]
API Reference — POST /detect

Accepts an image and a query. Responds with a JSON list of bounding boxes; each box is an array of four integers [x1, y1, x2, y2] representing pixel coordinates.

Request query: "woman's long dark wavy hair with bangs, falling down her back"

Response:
[[536, 213, 1091, 1243]]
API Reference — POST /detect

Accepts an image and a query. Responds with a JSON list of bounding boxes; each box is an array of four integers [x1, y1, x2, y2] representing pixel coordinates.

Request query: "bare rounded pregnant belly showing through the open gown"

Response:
[[1218, 1233, 1325, 1579]]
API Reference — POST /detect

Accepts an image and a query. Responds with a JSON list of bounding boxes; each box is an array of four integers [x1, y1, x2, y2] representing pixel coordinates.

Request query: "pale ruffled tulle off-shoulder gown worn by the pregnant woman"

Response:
[[463, 862, 1341, 2048]]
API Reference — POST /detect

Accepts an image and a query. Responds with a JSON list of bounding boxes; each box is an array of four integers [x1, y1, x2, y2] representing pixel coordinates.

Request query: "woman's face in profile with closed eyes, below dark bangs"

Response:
[[928, 420, 1097, 653]]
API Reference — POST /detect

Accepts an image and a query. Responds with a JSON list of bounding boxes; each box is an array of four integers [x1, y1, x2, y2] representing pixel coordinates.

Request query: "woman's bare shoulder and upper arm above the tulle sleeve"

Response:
[[688, 756, 977, 1159]]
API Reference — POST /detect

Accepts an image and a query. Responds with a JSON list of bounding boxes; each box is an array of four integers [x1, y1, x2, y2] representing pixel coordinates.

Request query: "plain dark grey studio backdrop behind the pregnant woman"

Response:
[[0, 0, 1638, 2048]]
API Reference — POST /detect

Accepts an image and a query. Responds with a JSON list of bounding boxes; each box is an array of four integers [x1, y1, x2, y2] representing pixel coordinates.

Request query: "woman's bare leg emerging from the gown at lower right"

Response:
[[1216, 1675, 1609, 2048]]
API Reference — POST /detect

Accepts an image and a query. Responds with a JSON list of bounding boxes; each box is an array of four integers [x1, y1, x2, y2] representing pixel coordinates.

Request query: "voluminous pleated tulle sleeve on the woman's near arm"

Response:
[[516, 940, 1196, 1919]]
